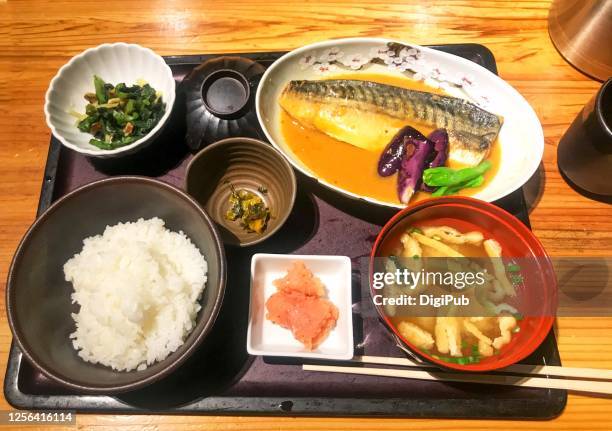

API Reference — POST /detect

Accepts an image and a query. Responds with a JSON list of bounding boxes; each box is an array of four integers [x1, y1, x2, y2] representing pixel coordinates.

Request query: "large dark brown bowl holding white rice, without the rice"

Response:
[[6, 177, 226, 394]]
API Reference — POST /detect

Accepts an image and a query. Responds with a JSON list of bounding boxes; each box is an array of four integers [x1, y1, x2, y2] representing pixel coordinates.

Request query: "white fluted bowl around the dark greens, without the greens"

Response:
[[45, 43, 175, 157]]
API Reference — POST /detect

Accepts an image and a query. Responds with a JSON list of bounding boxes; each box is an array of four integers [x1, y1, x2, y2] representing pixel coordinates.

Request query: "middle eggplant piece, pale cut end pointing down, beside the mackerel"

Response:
[[397, 129, 434, 204]]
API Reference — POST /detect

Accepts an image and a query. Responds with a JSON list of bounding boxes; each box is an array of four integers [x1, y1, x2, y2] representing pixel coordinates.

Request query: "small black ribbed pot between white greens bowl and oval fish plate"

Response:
[[181, 56, 266, 150]]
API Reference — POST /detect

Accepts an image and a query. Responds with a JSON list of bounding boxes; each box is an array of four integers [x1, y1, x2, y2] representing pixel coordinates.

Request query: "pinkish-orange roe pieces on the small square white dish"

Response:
[[266, 261, 338, 350]]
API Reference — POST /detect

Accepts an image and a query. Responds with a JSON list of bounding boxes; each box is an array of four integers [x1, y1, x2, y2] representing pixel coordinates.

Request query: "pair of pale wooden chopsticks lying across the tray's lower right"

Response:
[[303, 356, 612, 394]]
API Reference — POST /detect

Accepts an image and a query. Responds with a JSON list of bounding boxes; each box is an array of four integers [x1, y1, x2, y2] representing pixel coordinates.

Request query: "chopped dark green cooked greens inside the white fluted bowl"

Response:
[[78, 75, 166, 150]]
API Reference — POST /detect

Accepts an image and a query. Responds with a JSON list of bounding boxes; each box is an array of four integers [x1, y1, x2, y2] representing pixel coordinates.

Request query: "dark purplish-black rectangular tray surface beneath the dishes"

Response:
[[4, 44, 567, 419]]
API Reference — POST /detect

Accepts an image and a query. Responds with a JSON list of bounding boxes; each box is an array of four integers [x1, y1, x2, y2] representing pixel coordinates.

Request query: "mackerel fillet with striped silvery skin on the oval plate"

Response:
[[279, 79, 503, 166]]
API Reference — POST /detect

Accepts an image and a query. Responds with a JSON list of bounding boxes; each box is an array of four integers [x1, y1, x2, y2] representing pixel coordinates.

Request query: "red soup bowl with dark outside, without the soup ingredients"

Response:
[[369, 196, 557, 371]]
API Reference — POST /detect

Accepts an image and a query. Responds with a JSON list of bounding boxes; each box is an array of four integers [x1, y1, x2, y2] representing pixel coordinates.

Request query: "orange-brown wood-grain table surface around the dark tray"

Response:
[[0, 0, 612, 430]]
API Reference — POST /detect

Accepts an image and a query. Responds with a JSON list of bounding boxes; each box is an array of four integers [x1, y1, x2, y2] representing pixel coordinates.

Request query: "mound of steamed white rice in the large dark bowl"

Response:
[[64, 218, 208, 371]]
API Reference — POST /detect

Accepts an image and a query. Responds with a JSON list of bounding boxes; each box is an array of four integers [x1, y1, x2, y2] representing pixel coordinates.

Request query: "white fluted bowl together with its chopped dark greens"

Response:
[[45, 43, 175, 157]]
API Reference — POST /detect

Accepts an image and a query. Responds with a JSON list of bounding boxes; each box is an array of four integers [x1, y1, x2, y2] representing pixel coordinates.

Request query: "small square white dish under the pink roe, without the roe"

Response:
[[247, 253, 353, 360]]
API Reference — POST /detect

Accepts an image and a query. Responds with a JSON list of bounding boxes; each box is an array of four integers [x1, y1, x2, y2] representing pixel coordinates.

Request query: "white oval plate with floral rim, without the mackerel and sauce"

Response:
[[255, 38, 544, 208]]
